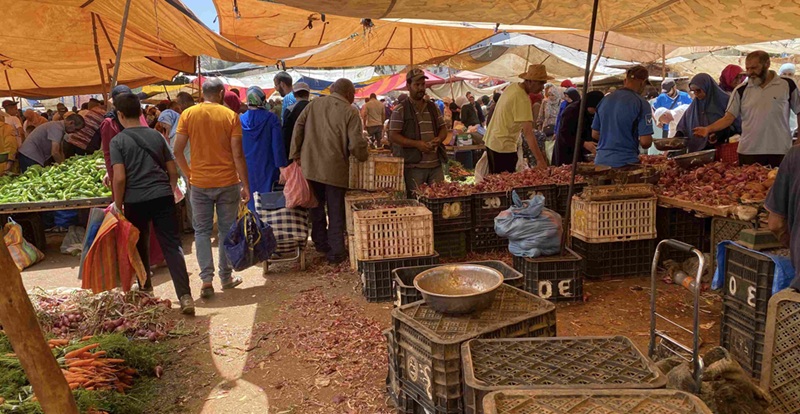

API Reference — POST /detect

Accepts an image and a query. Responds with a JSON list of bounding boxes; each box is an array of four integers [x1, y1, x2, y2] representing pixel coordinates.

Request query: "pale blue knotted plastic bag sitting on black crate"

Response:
[[494, 191, 562, 257]]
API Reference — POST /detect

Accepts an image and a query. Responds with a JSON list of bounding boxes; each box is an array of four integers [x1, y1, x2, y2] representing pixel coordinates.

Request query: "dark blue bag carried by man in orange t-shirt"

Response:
[[223, 204, 278, 272]]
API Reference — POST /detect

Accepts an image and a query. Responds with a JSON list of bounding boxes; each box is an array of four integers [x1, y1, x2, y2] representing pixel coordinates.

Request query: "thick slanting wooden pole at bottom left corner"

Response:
[[0, 243, 78, 414]]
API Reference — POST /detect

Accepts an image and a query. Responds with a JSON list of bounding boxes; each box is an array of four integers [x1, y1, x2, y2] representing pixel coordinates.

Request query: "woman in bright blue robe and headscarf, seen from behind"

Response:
[[239, 86, 289, 212]]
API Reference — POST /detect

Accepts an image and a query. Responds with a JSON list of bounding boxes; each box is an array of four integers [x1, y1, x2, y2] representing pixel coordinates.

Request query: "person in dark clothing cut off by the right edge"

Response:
[[765, 145, 800, 290]]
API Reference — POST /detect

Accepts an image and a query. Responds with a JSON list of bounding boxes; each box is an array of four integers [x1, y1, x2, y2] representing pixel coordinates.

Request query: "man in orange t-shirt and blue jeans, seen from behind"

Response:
[[174, 79, 250, 299]]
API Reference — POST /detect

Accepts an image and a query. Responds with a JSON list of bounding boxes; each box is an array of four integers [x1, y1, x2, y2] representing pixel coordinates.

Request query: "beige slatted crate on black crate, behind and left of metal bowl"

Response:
[[353, 200, 434, 260]]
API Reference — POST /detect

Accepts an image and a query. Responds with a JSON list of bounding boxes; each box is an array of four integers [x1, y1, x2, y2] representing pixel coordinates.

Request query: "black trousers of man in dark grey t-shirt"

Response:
[[125, 196, 192, 299]]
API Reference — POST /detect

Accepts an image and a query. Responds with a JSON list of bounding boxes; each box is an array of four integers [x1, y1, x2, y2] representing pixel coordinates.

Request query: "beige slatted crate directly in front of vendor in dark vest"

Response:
[[349, 154, 406, 191]]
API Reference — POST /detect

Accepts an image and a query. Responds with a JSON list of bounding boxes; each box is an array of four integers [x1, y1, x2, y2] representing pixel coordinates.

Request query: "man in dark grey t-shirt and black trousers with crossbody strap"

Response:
[[110, 93, 194, 315]]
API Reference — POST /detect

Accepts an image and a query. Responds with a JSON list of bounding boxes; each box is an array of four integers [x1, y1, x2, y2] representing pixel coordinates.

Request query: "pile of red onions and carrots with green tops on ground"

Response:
[[0, 290, 180, 414]]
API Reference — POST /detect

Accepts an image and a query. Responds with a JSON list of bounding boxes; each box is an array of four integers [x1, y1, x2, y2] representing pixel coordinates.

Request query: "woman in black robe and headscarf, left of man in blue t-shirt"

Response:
[[553, 90, 604, 166]]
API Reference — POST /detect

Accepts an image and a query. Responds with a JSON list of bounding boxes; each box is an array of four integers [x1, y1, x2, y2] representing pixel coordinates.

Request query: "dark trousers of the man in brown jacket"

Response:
[[308, 180, 347, 261]]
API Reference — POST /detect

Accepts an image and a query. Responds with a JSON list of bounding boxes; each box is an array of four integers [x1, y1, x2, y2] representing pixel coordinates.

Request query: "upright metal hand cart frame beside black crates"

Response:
[[648, 239, 706, 392]]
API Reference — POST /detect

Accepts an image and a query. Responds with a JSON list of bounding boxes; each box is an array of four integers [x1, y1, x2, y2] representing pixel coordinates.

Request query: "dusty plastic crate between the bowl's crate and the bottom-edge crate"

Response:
[[461, 336, 667, 414]]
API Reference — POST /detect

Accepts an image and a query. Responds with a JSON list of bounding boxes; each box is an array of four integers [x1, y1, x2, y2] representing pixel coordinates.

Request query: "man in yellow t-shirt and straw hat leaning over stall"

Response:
[[483, 65, 553, 174]]
